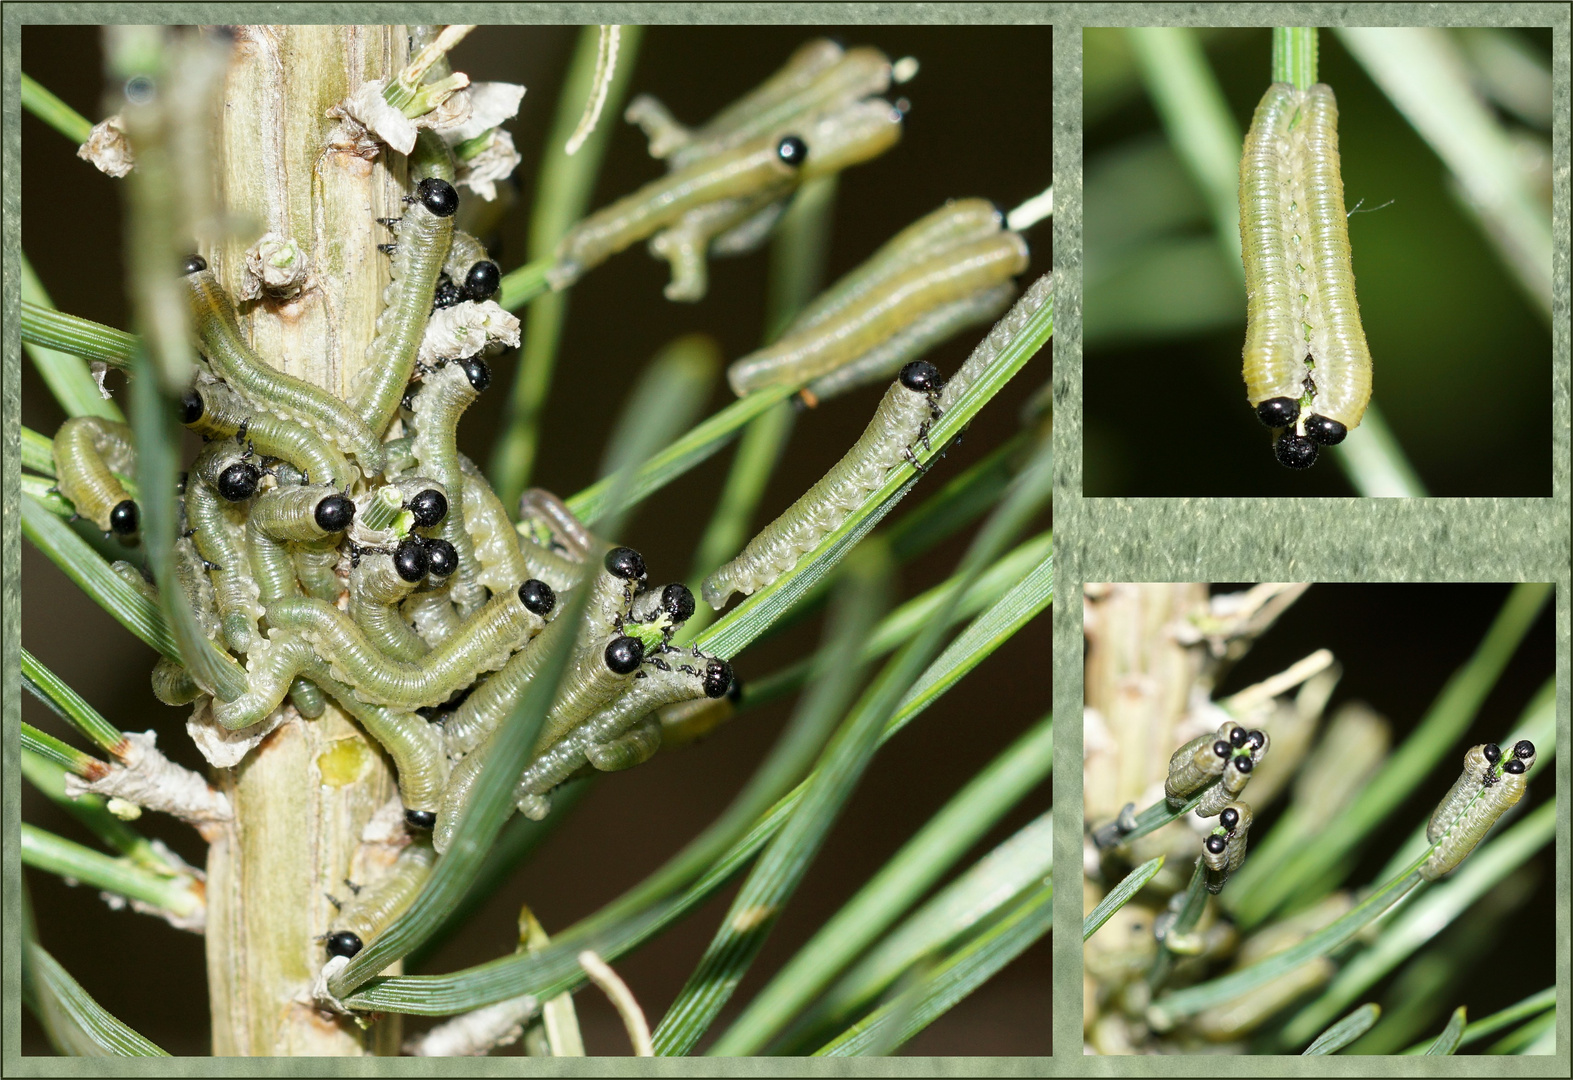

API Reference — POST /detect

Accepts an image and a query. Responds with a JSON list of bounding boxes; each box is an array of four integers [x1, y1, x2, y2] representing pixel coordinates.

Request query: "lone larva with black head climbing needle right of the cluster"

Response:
[[703, 360, 944, 610]]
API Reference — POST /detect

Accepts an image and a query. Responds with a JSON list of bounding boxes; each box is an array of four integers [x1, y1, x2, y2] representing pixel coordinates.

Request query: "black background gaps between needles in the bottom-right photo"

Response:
[[1213, 585, 1557, 1031]]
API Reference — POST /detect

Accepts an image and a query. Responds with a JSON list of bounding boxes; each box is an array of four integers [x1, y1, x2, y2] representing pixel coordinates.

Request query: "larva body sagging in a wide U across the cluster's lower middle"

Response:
[[267, 596, 544, 709]]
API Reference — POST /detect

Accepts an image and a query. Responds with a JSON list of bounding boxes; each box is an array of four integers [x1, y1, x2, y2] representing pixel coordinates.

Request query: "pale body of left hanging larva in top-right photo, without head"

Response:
[[1240, 83, 1306, 407]]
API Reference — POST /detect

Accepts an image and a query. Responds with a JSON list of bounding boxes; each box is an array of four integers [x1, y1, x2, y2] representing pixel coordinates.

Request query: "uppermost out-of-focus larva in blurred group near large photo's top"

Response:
[[623, 38, 890, 168]]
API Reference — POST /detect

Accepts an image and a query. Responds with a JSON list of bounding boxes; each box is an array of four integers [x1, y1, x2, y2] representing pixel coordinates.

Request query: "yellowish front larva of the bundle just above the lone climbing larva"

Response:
[[727, 233, 1027, 398]]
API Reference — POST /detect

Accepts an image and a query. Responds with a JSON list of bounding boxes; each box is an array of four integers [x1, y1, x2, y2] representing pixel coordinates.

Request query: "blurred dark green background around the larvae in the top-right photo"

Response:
[[1082, 28, 1554, 497]]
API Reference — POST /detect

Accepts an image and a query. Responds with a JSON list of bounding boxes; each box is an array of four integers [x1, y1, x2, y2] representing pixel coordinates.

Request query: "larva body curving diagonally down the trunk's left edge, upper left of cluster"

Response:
[[186, 270, 382, 473]]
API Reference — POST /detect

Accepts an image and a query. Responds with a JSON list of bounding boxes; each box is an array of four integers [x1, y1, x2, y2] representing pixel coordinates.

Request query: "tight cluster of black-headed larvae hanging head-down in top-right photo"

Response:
[[1240, 83, 1372, 468]]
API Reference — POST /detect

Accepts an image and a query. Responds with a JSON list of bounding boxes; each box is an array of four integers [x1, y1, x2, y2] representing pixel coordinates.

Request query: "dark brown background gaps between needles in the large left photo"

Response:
[[20, 27, 1051, 1055]]
